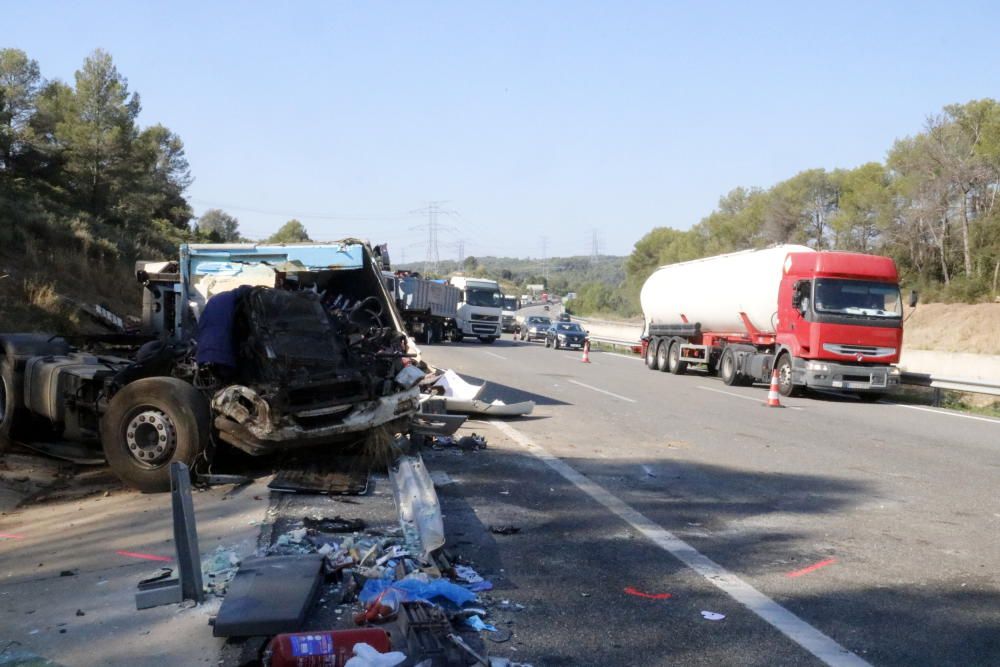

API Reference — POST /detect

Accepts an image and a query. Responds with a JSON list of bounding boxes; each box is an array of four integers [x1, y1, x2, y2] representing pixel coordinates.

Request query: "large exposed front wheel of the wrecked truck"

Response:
[[101, 377, 212, 493]]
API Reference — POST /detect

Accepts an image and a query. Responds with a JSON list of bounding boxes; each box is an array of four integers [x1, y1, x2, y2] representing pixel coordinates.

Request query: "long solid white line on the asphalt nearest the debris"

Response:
[[490, 420, 869, 667]]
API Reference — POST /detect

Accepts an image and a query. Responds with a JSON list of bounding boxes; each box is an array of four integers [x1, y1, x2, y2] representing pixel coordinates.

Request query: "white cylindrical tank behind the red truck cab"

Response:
[[639, 245, 814, 333]]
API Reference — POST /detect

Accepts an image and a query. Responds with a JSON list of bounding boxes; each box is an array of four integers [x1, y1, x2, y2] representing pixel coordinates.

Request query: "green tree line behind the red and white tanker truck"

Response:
[[617, 99, 1000, 312]]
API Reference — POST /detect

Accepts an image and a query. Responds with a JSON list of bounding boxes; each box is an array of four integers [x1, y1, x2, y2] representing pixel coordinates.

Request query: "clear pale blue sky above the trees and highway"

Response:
[[7, 0, 1000, 260]]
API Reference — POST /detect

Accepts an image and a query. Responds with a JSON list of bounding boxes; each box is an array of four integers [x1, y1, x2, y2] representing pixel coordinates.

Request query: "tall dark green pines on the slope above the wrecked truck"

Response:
[[0, 48, 309, 260]]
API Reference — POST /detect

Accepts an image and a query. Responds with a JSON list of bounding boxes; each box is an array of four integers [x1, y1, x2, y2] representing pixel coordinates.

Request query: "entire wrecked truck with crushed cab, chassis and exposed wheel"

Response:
[[0, 239, 423, 491]]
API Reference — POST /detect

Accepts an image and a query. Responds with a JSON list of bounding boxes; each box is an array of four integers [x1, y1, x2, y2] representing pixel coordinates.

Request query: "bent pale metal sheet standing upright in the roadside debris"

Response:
[[389, 454, 444, 561]]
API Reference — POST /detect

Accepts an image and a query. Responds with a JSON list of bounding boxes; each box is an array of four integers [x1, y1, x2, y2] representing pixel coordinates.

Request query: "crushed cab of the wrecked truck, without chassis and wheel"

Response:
[[140, 240, 418, 455]]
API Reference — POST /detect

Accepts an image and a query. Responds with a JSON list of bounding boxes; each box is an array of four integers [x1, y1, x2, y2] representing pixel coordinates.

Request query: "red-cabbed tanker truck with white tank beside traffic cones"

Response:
[[640, 245, 917, 401]]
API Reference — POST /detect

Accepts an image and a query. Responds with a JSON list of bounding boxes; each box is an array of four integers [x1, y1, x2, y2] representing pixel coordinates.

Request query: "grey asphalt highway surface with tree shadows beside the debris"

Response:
[[416, 328, 1000, 666]]
